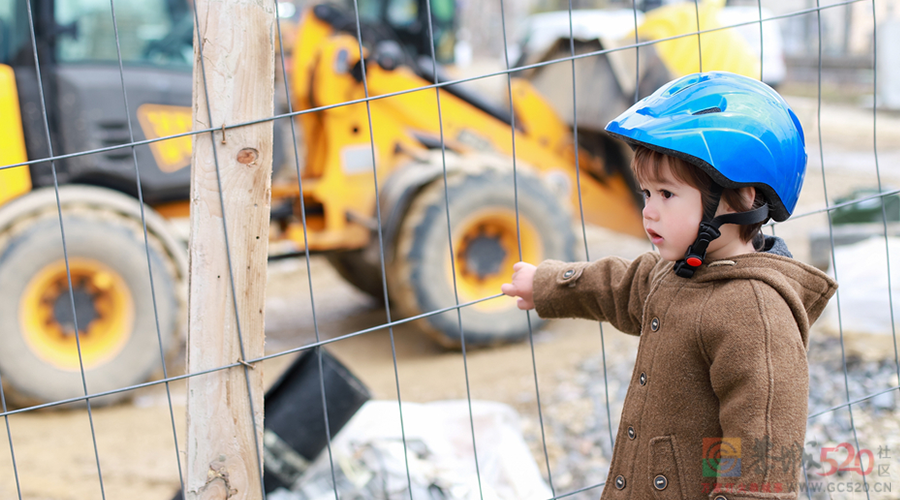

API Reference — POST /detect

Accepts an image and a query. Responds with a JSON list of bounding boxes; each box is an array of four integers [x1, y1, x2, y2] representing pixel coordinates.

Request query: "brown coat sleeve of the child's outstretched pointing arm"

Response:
[[534, 252, 660, 335]]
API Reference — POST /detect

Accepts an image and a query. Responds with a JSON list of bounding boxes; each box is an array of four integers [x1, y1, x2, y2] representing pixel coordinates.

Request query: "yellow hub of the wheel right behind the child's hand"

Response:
[[447, 207, 544, 310]]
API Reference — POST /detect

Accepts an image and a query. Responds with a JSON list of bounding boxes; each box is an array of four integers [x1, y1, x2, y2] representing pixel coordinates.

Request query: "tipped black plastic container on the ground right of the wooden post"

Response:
[[172, 348, 371, 500]]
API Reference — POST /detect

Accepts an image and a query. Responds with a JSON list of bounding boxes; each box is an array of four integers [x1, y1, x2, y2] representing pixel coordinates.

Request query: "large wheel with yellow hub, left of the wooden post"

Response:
[[0, 203, 183, 405]]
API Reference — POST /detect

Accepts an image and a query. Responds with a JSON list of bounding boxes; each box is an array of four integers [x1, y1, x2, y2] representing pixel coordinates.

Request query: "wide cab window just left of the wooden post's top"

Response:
[[54, 0, 193, 66]]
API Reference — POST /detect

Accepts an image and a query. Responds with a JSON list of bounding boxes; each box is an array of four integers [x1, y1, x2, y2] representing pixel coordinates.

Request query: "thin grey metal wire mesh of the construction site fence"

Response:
[[0, 0, 900, 500]]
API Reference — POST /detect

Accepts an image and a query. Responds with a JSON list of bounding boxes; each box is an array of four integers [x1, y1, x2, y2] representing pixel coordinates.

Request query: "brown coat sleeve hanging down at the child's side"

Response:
[[700, 280, 809, 500]]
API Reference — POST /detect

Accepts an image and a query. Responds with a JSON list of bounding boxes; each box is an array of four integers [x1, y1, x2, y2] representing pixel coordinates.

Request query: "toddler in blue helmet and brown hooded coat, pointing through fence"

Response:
[[501, 72, 837, 500]]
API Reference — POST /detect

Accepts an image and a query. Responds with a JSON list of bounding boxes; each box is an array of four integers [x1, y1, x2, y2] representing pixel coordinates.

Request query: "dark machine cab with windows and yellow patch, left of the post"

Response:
[[0, 0, 193, 203]]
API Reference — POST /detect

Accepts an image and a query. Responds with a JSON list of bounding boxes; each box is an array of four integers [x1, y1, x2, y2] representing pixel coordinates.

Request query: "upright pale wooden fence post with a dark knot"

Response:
[[184, 0, 275, 500]]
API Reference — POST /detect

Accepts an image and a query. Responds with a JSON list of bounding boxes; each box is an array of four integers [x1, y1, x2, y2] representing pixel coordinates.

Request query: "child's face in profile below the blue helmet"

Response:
[[641, 159, 703, 261]]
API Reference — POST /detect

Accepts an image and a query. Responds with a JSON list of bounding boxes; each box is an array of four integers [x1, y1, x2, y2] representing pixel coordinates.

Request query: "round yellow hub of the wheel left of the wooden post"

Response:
[[19, 258, 134, 371]]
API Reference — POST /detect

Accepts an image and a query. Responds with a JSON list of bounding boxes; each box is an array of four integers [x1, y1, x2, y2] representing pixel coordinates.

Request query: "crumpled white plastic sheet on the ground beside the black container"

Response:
[[269, 400, 552, 500]]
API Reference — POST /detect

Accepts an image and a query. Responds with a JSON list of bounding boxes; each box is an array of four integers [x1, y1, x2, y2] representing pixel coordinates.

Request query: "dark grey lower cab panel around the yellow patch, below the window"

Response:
[[16, 63, 193, 203]]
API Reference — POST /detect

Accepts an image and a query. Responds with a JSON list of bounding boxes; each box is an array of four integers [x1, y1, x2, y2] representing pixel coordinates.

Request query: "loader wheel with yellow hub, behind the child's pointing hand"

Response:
[[389, 168, 575, 347]]
